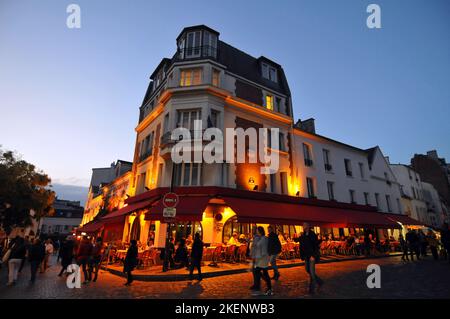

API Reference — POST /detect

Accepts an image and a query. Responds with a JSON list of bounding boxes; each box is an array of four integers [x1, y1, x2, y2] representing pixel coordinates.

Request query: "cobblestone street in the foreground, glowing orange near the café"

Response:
[[0, 257, 450, 299]]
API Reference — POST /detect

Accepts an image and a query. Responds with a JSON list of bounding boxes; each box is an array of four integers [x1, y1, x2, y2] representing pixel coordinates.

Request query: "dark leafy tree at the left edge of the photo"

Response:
[[0, 149, 55, 234]]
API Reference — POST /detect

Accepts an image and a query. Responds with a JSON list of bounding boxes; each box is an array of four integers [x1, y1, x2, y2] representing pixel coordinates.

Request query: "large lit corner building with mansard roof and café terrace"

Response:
[[80, 25, 414, 247]]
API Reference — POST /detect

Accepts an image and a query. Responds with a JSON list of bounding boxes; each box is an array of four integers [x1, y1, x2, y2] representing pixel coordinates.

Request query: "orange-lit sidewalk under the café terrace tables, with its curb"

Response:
[[102, 252, 402, 281]]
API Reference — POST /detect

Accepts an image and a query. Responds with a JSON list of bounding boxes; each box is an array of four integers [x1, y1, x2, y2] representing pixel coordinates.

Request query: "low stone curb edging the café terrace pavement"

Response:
[[101, 253, 402, 282]]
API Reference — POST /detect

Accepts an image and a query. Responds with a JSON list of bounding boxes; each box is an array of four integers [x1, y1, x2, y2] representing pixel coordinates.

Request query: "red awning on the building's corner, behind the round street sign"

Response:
[[145, 196, 211, 221]]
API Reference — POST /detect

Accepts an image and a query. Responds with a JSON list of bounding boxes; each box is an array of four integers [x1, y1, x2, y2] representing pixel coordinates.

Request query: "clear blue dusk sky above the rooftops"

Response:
[[0, 0, 450, 186]]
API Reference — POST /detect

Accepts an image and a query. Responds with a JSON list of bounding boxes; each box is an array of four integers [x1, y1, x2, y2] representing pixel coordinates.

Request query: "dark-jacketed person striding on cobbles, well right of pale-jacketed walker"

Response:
[[300, 223, 323, 294]]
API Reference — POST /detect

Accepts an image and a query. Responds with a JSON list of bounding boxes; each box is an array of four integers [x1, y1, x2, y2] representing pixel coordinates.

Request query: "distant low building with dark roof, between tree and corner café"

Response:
[[39, 198, 84, 236]]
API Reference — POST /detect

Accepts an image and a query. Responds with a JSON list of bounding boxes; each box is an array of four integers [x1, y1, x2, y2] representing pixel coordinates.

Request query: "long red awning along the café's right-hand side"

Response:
[[223, 197, 399, 228]]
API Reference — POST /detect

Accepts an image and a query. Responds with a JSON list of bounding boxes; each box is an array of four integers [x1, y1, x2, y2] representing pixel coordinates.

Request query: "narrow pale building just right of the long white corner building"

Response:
[[391, 164, 432, 225]]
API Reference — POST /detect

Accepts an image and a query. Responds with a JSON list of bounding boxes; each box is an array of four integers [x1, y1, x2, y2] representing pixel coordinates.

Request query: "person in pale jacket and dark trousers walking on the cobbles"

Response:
[[251, 226, 273, 296]]
